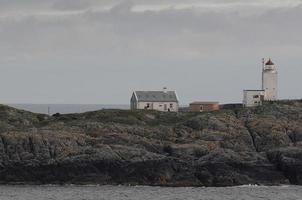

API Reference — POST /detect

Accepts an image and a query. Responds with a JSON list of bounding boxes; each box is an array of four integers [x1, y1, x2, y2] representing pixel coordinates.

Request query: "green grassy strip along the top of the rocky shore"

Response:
[[0, 99, 302, 131]]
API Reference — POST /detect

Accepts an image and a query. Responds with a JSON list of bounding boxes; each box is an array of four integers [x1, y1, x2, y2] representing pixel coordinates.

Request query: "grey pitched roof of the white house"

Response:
[[134, 91, 178, 102]]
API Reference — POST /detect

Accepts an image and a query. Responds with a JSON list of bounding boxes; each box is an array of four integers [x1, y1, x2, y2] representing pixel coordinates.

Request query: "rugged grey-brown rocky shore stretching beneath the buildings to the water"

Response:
[[0, 101, 302, 186]]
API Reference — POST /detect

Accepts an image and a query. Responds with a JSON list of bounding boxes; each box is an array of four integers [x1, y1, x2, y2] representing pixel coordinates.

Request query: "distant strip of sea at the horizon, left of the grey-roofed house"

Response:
[[9, 104, 130, 115]]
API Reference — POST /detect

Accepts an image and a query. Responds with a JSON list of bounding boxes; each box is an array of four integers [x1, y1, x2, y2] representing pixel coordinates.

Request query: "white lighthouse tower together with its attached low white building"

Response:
[[243, 59, 278, 107]]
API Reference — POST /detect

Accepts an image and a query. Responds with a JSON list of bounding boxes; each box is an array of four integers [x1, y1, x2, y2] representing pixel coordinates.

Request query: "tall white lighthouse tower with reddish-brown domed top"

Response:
[[262, 59, 278, 101]]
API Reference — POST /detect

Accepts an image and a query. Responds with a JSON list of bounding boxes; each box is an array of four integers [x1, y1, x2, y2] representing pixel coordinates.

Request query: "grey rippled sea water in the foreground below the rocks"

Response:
[[0, 185, 302, 200]]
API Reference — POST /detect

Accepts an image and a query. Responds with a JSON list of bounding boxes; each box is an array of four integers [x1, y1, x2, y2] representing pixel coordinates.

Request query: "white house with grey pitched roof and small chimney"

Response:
[[130, 90, 179, 112]]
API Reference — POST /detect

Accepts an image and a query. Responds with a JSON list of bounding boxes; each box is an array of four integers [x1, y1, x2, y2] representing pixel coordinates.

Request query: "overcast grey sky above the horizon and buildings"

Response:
[[0, 0, 302, 104]]
